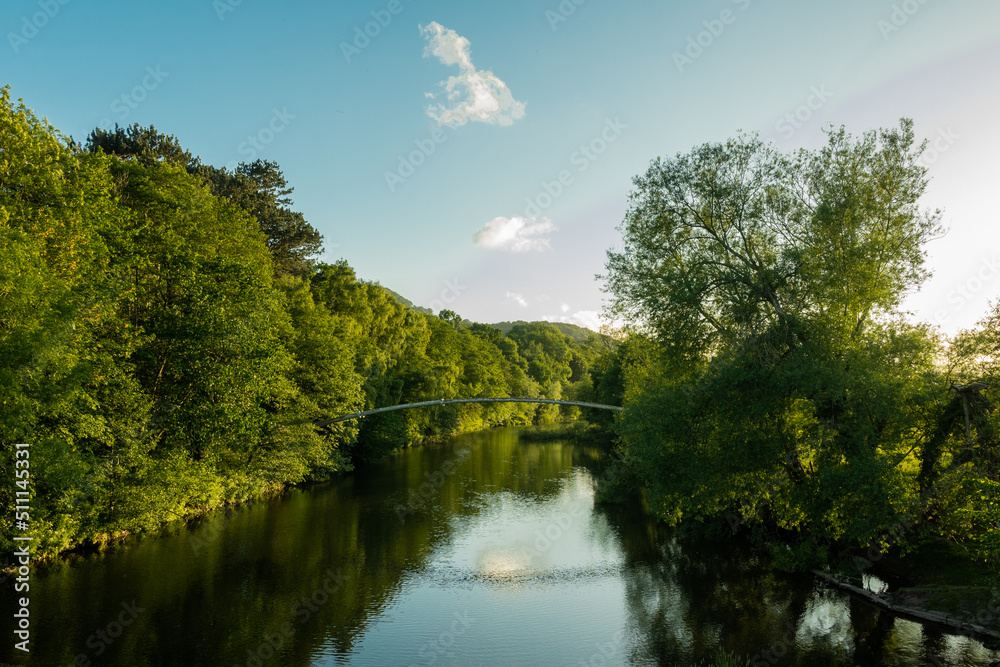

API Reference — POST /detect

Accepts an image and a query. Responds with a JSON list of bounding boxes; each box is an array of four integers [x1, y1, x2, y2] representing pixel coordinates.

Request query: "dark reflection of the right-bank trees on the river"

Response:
[[614, 512, 1000, 666]]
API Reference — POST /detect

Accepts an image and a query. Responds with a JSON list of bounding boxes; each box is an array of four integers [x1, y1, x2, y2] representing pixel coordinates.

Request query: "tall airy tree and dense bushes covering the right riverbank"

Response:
[[593, 121, 1000, 588]]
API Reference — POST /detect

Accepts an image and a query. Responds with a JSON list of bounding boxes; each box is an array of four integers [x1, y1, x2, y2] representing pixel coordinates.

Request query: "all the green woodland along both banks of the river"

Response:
[[0, 89, 1000, 620]]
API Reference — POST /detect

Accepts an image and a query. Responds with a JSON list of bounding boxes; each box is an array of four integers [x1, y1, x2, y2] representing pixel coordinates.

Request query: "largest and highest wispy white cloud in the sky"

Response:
[[420, 21, 524, 127]]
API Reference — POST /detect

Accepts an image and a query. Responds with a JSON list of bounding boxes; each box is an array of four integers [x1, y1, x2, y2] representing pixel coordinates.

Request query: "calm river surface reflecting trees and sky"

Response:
[[0, 429, 1000, 667]]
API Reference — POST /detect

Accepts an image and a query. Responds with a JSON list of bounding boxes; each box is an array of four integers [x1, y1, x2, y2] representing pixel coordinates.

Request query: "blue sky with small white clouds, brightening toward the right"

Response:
[[0, 0, 1000, 332]]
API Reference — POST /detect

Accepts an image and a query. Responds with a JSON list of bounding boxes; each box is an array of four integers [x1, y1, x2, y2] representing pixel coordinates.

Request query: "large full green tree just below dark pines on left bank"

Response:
[[99, 161, 324, 513]]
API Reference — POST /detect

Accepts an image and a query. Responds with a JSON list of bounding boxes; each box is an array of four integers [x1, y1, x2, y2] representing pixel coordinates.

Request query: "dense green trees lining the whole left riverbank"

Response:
[[0, 89, 597, 556]]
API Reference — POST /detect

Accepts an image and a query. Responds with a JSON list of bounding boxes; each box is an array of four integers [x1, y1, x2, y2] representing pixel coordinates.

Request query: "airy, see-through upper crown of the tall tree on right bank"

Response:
[[607, 121, 940, 356]]
